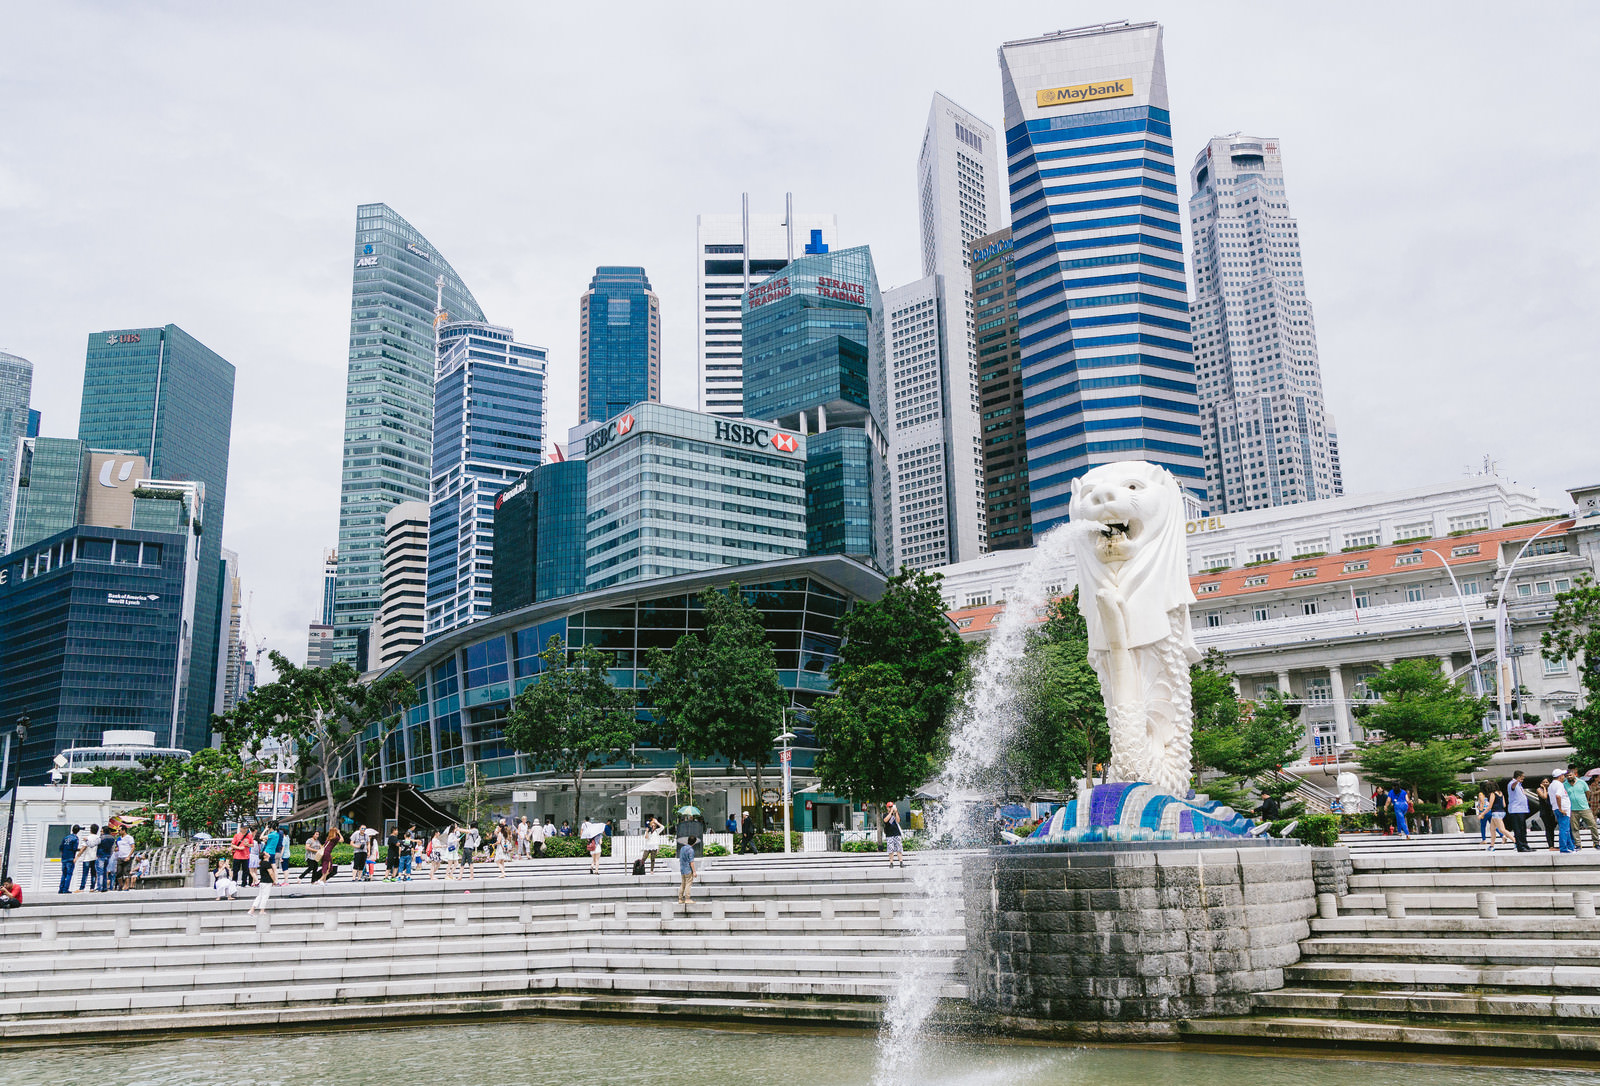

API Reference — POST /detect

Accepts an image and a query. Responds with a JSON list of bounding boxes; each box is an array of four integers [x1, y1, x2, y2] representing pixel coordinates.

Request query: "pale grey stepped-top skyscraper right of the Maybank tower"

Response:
[[1189, 133, 1344, 513]]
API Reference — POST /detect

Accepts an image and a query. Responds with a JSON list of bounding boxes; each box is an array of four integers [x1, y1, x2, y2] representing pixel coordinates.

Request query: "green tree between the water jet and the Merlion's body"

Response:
[[1011, 593, 1110, 790]]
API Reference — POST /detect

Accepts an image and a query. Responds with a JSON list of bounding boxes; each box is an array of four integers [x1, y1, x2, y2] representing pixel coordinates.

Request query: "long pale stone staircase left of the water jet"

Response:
[[0, 854, 965, 1038]]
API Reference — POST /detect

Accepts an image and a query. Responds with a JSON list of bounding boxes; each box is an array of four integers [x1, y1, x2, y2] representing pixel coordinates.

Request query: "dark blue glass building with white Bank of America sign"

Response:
[[0, 524, 196, 784]]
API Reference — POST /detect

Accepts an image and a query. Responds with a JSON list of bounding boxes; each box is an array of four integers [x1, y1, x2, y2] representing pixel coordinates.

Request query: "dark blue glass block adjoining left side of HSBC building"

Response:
[[491, 461, 589, 614]]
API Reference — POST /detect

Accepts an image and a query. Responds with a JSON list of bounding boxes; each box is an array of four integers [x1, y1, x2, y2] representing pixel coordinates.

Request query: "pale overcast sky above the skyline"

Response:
[[0, 0, 1600, 674]]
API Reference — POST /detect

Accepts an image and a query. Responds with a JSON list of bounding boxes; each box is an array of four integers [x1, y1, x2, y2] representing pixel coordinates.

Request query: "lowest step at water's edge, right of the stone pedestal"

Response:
[[1178, 1014, 1600, 1060]]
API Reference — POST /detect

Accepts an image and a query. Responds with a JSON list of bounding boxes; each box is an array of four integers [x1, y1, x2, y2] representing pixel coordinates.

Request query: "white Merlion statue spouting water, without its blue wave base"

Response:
[[1070, 461, 1200, 797]]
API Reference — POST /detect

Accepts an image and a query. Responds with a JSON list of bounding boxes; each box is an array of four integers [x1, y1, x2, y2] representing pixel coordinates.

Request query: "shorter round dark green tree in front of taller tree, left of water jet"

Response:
[[811, 664, 928, 832]]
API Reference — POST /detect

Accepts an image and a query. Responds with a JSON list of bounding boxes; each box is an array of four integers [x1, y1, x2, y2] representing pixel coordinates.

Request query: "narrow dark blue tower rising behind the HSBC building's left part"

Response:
[[579, 267, 661, 425]]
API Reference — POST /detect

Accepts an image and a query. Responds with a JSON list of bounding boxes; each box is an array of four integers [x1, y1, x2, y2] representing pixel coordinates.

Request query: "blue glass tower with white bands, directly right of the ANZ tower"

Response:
[[428, 321, 546, 636]]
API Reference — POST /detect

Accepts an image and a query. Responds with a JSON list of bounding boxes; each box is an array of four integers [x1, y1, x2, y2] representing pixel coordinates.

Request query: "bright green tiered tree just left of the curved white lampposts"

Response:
[[1355, 657, 1494, 801]]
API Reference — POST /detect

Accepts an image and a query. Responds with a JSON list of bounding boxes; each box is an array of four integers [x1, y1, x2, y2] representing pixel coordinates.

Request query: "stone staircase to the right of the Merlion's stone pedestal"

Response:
[[1182, 836, 1600, 1054]]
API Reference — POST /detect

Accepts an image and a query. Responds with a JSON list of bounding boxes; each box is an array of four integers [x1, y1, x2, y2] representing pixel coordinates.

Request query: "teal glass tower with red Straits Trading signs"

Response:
[[742, 245, 894, 569]]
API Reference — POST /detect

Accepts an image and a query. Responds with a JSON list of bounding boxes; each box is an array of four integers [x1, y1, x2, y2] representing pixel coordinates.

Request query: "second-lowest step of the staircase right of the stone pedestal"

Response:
[[1256, 988, 1600, 1027]]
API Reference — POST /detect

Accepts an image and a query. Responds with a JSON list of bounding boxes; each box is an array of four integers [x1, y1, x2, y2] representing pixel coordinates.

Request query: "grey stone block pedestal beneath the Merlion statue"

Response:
[[962, 840, 1317, 1038]]
